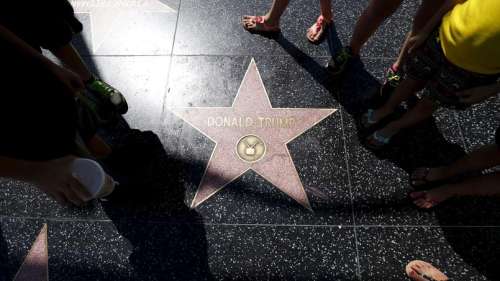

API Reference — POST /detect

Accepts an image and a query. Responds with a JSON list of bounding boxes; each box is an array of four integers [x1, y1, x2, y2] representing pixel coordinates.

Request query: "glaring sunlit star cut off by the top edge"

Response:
[[70, 0, 176, 52]]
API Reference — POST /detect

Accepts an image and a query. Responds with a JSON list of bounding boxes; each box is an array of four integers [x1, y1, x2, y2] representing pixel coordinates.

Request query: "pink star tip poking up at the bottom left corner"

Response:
[[14, 224, 49, 281]]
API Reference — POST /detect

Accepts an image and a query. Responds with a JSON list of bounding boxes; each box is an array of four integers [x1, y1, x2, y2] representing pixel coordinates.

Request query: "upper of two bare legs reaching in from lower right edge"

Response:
[[414, 144, 500, 181]]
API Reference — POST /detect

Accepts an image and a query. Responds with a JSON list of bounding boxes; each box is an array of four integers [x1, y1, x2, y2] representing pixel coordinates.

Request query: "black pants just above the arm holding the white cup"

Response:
[[0, 51, 77, 160]]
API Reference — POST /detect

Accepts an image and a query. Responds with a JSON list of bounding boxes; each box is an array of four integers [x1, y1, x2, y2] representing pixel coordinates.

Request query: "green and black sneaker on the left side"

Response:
[[85, 76, 128, 115]]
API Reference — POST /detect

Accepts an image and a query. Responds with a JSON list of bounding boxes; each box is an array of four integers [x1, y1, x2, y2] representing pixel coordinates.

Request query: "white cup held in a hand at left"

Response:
[[72, 158, 117, 199]]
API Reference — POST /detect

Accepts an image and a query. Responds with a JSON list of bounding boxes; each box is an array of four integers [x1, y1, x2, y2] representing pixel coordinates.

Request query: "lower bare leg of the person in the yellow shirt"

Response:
[[378, 98, 435, 137]]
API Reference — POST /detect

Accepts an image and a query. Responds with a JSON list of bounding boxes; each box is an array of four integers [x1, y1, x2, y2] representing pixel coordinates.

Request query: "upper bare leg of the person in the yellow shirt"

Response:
[[373, 78, 426, 121]]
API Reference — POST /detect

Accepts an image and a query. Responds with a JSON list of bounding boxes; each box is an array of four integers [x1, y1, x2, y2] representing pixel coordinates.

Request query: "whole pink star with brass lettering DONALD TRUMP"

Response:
[[170, 59, 336, 210]]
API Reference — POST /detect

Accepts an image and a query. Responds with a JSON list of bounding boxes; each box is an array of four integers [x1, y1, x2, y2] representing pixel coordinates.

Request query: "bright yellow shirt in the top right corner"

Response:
[[439, 0, 500, 74]]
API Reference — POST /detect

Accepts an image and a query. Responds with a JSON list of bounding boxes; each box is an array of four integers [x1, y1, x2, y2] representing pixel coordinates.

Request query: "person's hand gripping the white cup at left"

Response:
[[34, 156, 92, 206]]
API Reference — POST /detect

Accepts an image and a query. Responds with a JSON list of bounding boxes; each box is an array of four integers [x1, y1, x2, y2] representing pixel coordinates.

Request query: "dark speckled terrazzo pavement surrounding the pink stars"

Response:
[[0, 0, 500, 281]]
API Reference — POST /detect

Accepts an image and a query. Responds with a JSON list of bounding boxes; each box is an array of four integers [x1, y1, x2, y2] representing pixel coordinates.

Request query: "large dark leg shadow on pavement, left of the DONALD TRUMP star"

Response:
[[98, 130, 212, 281]]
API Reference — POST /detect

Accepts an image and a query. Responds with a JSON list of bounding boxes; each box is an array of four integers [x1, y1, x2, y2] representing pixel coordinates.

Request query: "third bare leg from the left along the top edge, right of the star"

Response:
[[349, 0, 402, 55]]
